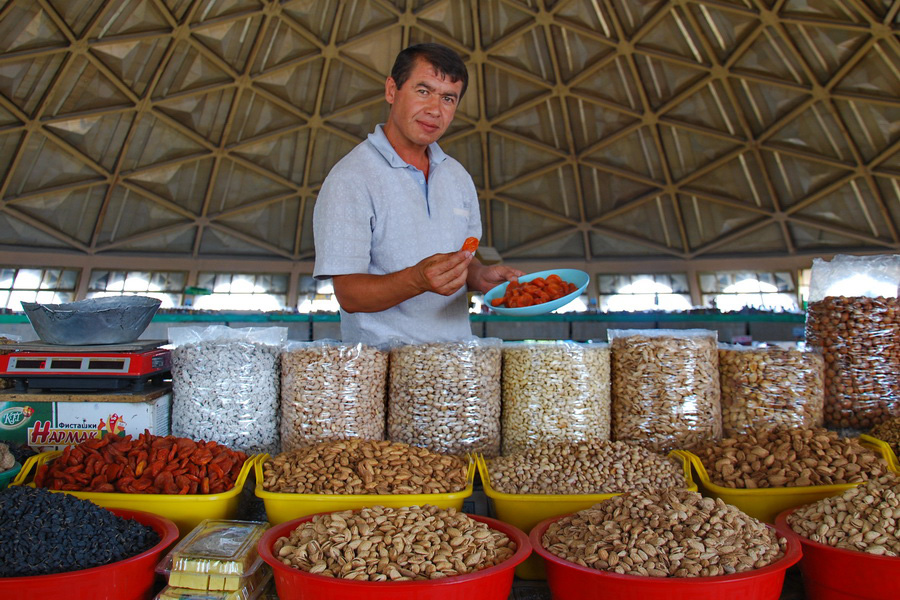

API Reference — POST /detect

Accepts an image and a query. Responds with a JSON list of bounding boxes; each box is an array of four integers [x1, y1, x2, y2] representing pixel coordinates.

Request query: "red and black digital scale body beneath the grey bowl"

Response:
[[0, 340, 172, 392]]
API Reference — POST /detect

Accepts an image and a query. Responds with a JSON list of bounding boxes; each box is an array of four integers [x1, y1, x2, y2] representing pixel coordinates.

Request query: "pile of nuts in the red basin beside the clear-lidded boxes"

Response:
[[272, 504, 516, 580]]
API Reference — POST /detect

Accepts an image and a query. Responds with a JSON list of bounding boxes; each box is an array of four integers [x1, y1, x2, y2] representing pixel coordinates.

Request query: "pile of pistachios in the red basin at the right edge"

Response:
[[787, 473, 900, 556]]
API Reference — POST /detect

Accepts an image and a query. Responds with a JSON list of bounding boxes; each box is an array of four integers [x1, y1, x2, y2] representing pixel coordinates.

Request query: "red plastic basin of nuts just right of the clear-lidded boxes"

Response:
[[258, 515, 531, 600]]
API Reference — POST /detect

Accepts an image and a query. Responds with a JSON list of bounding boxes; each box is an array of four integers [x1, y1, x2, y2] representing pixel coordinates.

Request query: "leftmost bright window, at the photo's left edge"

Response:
[[0, 267, 79, 311]]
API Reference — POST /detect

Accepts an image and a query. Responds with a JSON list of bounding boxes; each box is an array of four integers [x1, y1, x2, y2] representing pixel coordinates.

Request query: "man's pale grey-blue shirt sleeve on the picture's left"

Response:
[[313, 159, 375, 279]]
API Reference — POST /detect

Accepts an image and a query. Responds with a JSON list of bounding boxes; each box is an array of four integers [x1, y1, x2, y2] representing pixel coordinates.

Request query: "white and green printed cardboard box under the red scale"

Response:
[[0, 390, 172, 452]]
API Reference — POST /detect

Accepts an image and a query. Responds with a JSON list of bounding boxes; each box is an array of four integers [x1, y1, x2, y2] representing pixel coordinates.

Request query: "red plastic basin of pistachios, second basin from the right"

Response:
[[529, 515, 800, 600]]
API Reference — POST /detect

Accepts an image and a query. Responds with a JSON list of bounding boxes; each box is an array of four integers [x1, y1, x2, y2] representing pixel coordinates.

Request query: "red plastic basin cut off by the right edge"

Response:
[[775, 508, 900, 600]]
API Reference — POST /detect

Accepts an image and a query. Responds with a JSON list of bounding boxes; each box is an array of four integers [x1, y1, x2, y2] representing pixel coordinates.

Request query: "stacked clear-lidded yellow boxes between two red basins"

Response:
[[157, 519, 269, 592]]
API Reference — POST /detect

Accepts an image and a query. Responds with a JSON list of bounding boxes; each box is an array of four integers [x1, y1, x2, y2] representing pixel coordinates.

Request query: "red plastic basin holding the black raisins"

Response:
[[0, 508, 178, 600]]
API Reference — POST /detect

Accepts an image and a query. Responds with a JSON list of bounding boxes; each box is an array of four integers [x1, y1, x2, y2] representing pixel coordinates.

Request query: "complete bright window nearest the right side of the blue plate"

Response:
[[597, 273, 691, 312]]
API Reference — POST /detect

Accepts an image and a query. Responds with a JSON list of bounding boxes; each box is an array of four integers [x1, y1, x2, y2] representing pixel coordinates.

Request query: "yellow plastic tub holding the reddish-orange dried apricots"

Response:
[[10, 450, 256, 535]]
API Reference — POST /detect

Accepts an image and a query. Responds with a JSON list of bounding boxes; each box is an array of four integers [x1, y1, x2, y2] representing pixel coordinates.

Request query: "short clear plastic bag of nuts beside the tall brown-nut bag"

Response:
[[719, 344, 825, 435]]
